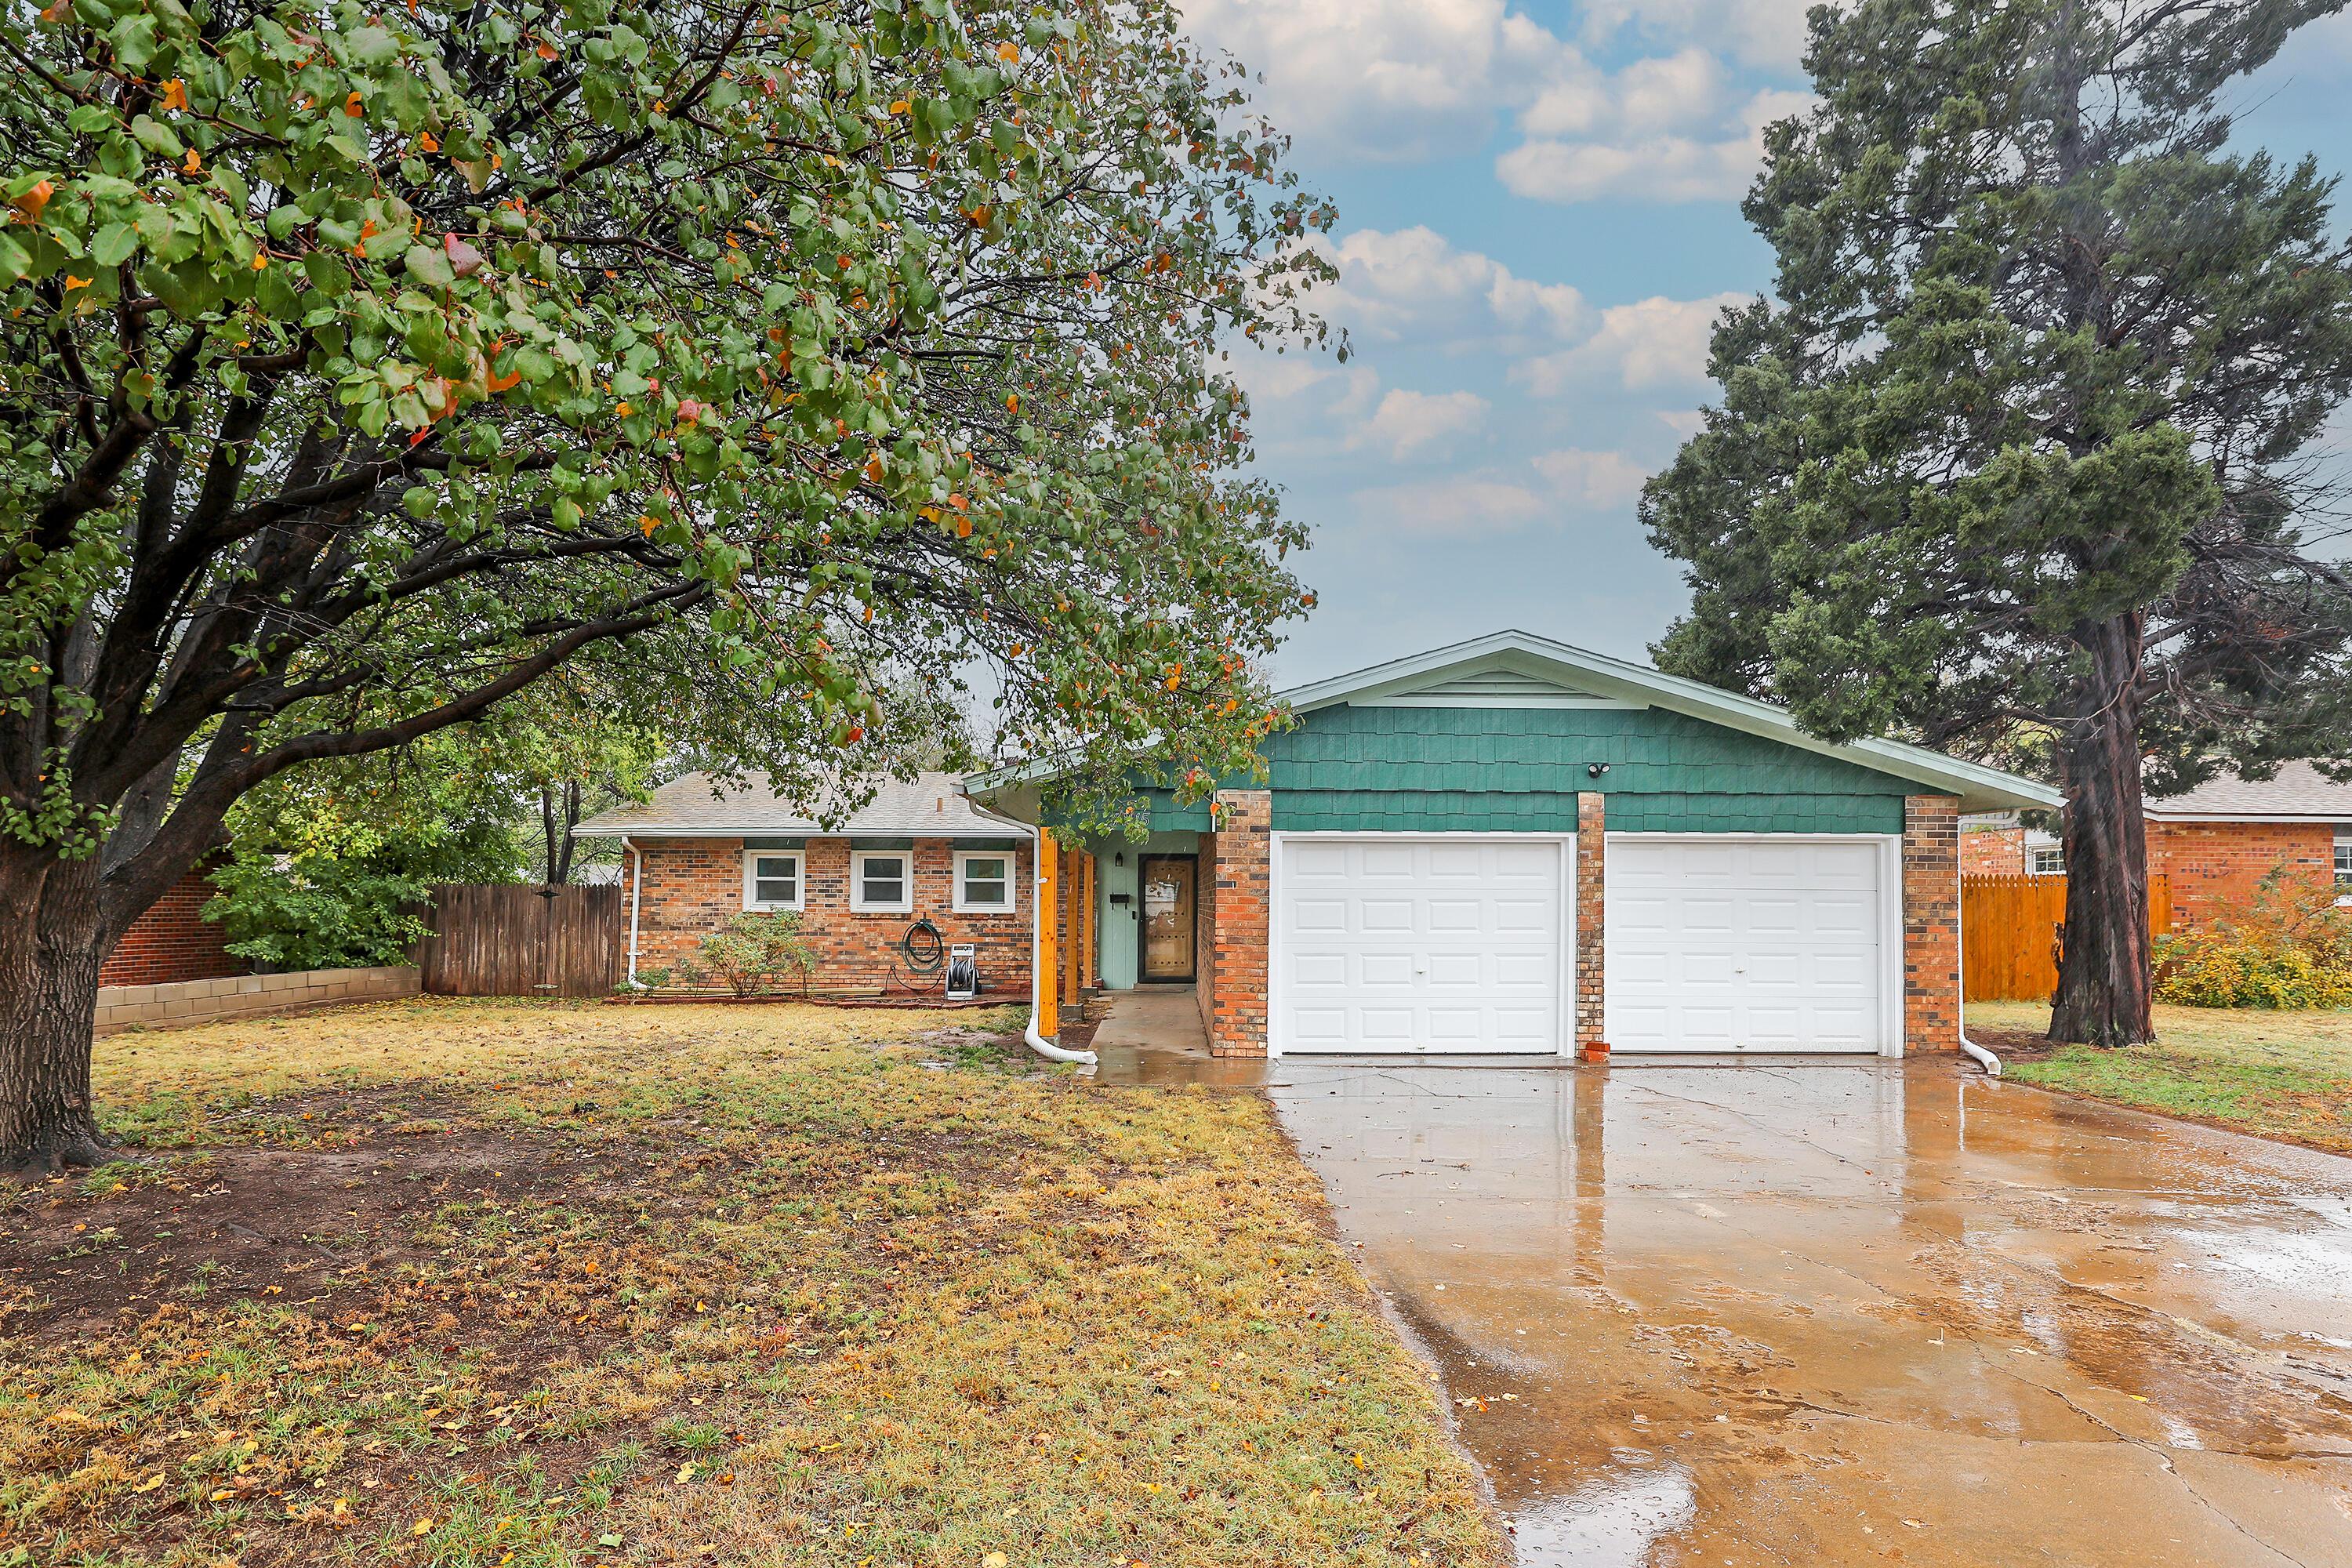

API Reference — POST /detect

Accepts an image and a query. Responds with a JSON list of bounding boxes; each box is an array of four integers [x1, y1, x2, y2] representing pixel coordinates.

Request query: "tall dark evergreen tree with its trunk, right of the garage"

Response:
[[1644, 0, 2352, 1044]]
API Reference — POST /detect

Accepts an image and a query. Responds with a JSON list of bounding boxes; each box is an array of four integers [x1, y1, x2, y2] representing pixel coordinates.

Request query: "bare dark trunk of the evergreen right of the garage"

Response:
[[2051, 616, 2157, 1046]]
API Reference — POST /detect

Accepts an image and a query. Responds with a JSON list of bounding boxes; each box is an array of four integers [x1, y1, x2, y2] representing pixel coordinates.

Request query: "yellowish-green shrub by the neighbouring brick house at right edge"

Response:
[[2157, 865, 2352, 1008]]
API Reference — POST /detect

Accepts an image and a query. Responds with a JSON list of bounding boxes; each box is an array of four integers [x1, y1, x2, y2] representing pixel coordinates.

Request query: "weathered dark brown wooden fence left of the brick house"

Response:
[[416, 881, 628, 996]]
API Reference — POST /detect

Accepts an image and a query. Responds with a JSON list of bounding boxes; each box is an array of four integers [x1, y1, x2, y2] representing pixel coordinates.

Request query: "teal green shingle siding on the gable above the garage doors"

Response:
[[1270, 706, 1917, 832]]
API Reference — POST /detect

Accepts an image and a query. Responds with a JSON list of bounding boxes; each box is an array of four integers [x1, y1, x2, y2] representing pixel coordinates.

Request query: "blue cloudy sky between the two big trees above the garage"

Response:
[[1188, 0, 2352, 687]]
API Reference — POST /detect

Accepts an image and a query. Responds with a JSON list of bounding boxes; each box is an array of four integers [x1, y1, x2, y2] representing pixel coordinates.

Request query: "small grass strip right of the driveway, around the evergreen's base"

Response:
[[1969, 1001, 2352, 1154]]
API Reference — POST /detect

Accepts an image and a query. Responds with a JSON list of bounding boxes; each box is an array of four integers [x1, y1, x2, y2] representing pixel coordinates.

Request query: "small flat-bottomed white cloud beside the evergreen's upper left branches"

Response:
[[1494, 86, 1811, 202]]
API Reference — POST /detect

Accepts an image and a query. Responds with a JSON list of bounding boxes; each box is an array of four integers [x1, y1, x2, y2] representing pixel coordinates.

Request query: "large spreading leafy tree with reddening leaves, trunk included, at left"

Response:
[[0, 0, 1329, 1161]]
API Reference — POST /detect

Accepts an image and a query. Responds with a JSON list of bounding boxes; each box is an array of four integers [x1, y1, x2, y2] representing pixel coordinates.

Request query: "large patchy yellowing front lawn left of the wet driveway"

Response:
[[0, 1001, 1508, 1568]]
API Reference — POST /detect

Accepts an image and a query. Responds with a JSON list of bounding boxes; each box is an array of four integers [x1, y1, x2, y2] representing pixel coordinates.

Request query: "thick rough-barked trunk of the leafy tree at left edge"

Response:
[[0, 844, 111, 1171]]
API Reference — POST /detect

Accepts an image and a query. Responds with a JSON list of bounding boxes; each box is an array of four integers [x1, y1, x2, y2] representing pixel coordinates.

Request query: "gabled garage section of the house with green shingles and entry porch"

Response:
[[971, 633, 2058, 1055]]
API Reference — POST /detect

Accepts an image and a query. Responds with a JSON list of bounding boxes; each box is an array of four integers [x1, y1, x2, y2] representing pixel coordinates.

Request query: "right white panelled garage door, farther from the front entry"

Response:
[[1606, 834, 1886, 1051]]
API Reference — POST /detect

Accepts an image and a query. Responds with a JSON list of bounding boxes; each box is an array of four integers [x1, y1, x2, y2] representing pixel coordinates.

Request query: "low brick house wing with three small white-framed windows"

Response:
[[574, 774, 1035, 994]]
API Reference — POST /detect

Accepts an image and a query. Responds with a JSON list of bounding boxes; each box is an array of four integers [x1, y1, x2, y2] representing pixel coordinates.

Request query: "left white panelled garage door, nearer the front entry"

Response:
[[1272, 832, 1569, 1053]]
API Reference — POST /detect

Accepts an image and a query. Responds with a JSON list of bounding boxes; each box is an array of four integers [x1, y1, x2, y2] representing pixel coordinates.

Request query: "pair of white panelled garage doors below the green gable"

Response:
[[1270, 834, 1889, 1055]]
